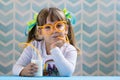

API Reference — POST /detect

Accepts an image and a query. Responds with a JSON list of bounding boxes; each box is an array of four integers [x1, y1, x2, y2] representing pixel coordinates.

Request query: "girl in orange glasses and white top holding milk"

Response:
[[13, 8, 79, 76]]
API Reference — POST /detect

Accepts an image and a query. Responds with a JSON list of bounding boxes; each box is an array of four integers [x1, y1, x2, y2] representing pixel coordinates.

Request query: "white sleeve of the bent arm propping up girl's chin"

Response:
[[50, 46, 77, 76]]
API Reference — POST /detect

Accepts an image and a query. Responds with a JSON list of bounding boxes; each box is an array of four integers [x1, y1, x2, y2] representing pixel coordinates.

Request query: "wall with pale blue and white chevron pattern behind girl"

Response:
[[0, 0, 120, 76]]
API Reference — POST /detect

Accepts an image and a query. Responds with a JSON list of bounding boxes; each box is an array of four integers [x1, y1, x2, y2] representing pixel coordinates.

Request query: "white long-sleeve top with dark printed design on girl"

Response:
[[12, 41, 77, 76]]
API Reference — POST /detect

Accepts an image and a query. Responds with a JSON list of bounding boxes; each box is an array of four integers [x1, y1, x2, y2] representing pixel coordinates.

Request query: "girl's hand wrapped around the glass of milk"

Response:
[[20, 63, 38, 76]]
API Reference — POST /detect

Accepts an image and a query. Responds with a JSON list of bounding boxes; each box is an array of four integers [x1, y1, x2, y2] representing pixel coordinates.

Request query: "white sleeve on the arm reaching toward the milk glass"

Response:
[[12, 47, 32, 75]]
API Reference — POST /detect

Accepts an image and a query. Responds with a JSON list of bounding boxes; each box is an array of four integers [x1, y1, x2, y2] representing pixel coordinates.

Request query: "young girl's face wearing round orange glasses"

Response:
[[42, 18, 68, 44]]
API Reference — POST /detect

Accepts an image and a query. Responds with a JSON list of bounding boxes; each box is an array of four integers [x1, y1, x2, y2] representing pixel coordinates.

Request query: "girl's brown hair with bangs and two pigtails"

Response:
[[28, 7, 80, 52]]
